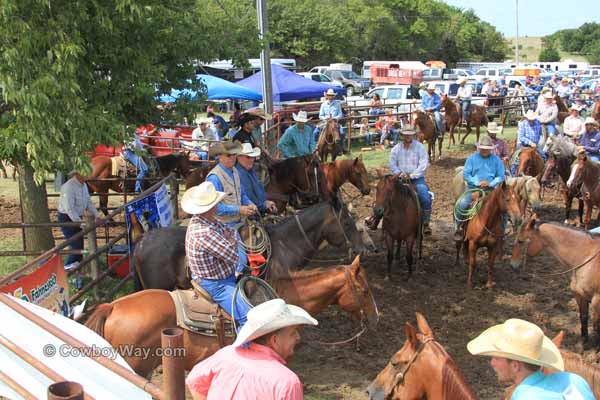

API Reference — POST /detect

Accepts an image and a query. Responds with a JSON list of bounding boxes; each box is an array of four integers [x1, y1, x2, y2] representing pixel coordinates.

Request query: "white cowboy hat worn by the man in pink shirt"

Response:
[[233, 299, 318, 347]]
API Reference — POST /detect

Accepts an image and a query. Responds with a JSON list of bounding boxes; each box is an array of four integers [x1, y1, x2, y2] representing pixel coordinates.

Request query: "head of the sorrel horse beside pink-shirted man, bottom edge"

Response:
[[367, 313, 451, 400]]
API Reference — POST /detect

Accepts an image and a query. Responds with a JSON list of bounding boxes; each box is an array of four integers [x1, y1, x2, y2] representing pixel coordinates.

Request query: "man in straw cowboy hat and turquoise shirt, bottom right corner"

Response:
[[467, 318, 595, 400]]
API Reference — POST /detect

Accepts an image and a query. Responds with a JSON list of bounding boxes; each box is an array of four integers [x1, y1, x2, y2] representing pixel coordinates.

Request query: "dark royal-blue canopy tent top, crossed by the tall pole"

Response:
[[236, 64, 346, 102]]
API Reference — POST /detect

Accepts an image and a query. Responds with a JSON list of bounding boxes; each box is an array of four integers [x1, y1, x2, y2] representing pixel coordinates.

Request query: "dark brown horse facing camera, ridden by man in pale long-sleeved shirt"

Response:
[[372, 170, 423, 279]]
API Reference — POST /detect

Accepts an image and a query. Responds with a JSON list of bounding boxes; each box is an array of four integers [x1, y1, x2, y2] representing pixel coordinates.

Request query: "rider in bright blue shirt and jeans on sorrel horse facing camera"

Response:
[[454, 136, 504, 241]]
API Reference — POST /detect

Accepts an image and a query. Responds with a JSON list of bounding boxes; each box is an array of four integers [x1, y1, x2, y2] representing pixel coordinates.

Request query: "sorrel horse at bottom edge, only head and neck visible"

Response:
[[367, 312, 477, 400]]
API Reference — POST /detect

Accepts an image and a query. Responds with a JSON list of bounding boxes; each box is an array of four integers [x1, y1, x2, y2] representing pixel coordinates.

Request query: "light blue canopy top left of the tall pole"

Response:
[[160, 74, 262, 103]]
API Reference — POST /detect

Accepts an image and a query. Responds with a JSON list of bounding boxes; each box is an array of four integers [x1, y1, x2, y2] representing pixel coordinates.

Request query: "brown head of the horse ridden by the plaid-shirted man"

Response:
[[338, 256, 379, 328]]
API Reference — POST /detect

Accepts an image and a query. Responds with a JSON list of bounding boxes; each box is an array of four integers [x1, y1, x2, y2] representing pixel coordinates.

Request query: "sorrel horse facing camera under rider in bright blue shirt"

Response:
[[456, 182, 522, 289]]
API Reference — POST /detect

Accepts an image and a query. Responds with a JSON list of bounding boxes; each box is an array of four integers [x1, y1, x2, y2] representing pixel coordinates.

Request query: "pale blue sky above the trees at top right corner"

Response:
[[442, 0, 600, 37]]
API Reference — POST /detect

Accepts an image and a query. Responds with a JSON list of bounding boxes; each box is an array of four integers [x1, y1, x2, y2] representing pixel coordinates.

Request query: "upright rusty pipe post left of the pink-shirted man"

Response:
[[160, 328, 185, 400]]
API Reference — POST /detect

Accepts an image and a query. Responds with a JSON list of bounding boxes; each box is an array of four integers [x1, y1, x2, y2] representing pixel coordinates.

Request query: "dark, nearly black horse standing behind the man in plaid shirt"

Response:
[[133, 200, 371, 290]]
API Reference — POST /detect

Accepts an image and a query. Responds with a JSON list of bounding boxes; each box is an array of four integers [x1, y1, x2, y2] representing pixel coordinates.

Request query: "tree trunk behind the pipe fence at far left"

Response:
[[16, 163, 54, 251]]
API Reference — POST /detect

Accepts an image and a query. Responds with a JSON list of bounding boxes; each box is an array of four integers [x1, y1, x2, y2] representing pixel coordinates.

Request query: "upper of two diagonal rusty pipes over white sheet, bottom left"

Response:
[[0, 293, 165, 399]]
